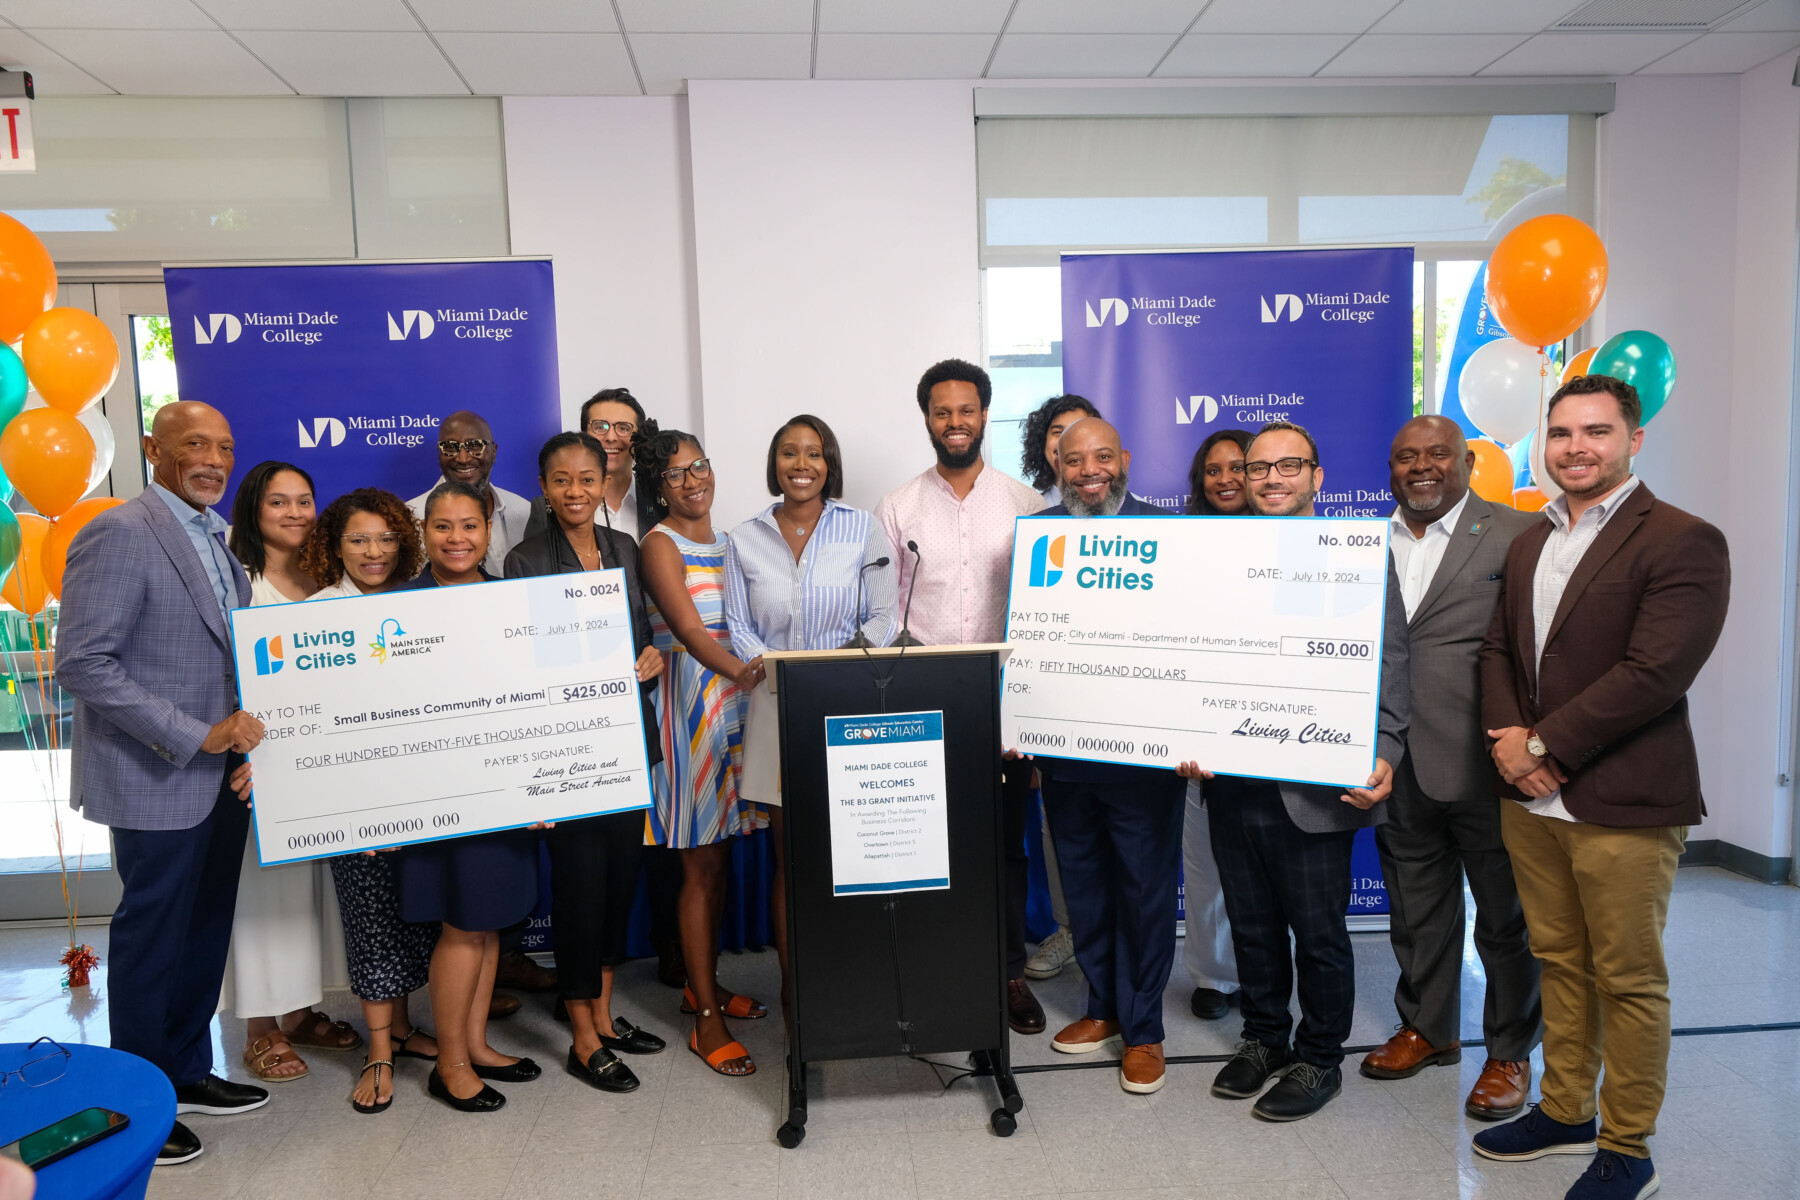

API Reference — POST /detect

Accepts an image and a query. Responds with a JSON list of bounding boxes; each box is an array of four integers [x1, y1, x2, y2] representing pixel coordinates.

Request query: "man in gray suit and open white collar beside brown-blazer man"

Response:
[[1363, 416, 1543, 1121]]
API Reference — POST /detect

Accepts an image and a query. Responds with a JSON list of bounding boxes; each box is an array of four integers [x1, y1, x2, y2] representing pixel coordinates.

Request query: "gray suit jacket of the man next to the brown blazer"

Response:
[[1406, 491, 1544, 802]]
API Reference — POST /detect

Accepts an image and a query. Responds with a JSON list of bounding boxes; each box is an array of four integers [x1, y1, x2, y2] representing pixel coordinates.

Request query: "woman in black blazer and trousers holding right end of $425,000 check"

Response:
[[506, 434, 664, 1092]]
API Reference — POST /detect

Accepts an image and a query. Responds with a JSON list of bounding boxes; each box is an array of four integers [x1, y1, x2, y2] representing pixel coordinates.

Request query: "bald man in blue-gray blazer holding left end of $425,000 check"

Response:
[[56, 401, 268, 1164]]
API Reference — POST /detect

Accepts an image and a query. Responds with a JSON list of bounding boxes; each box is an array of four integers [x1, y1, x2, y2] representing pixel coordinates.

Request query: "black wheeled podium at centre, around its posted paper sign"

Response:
[[765, 644, 1024, 1148]]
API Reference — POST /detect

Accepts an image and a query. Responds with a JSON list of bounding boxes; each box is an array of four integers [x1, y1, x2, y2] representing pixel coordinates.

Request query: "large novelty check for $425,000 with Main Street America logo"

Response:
[[230, 570, 650, 865]]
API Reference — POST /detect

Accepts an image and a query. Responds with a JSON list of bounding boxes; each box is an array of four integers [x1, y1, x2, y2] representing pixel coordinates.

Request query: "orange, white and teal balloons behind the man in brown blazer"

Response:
[[1456, 214, 1676, 511]]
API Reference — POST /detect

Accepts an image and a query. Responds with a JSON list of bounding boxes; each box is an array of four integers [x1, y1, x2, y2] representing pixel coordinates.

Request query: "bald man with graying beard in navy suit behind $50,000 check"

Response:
[[1037, 417, 1188, 1094]]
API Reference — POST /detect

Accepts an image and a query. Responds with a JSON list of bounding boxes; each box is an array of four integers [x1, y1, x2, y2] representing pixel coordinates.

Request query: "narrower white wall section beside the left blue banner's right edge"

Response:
[[504, 95, 700, 438]]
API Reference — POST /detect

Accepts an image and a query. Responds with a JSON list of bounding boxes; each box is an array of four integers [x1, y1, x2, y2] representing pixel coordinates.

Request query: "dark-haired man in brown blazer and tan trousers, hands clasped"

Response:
[[1474, 376, 1732, 1200]]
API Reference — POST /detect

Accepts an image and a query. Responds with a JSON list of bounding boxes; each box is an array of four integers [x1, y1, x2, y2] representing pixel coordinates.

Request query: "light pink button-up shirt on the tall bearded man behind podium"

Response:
[[875, 466, 1044, 646]]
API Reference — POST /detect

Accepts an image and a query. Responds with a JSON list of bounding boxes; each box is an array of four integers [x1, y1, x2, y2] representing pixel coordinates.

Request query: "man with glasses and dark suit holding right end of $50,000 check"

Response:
[[1179, 421, 1411, 1121]]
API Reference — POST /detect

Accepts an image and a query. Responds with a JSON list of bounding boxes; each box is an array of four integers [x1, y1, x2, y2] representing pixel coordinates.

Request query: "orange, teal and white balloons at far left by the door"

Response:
[[0, 212, 121, 615]]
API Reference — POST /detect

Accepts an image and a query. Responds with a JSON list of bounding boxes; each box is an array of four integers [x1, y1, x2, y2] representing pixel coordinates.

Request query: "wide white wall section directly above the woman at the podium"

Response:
[[688, 81, 981, 527]]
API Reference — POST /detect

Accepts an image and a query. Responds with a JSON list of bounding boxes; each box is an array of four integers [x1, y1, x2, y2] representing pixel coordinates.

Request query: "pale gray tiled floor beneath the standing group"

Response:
[[0, 867, 1800, 1200]]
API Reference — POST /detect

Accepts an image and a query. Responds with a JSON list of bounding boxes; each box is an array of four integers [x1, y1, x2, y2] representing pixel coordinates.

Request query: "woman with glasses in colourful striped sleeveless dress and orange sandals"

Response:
[[632, 421, 769, 1076]]
